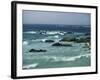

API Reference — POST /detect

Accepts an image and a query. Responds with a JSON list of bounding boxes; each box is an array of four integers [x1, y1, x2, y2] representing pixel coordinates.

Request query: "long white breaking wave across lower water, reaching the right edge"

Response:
[[24, 54, 90, 62]]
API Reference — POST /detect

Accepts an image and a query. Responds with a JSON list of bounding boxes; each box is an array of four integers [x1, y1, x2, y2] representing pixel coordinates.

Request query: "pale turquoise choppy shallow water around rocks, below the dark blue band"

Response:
[[23, 32, 91, 69]]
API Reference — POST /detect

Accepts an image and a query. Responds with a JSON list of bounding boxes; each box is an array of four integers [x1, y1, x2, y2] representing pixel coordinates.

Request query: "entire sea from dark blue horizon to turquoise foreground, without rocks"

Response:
[[22, 25, 91, 69]]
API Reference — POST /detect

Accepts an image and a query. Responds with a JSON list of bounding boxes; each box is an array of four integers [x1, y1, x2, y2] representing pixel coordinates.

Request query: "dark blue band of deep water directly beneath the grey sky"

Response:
[[23, 24, 90, 32]]
